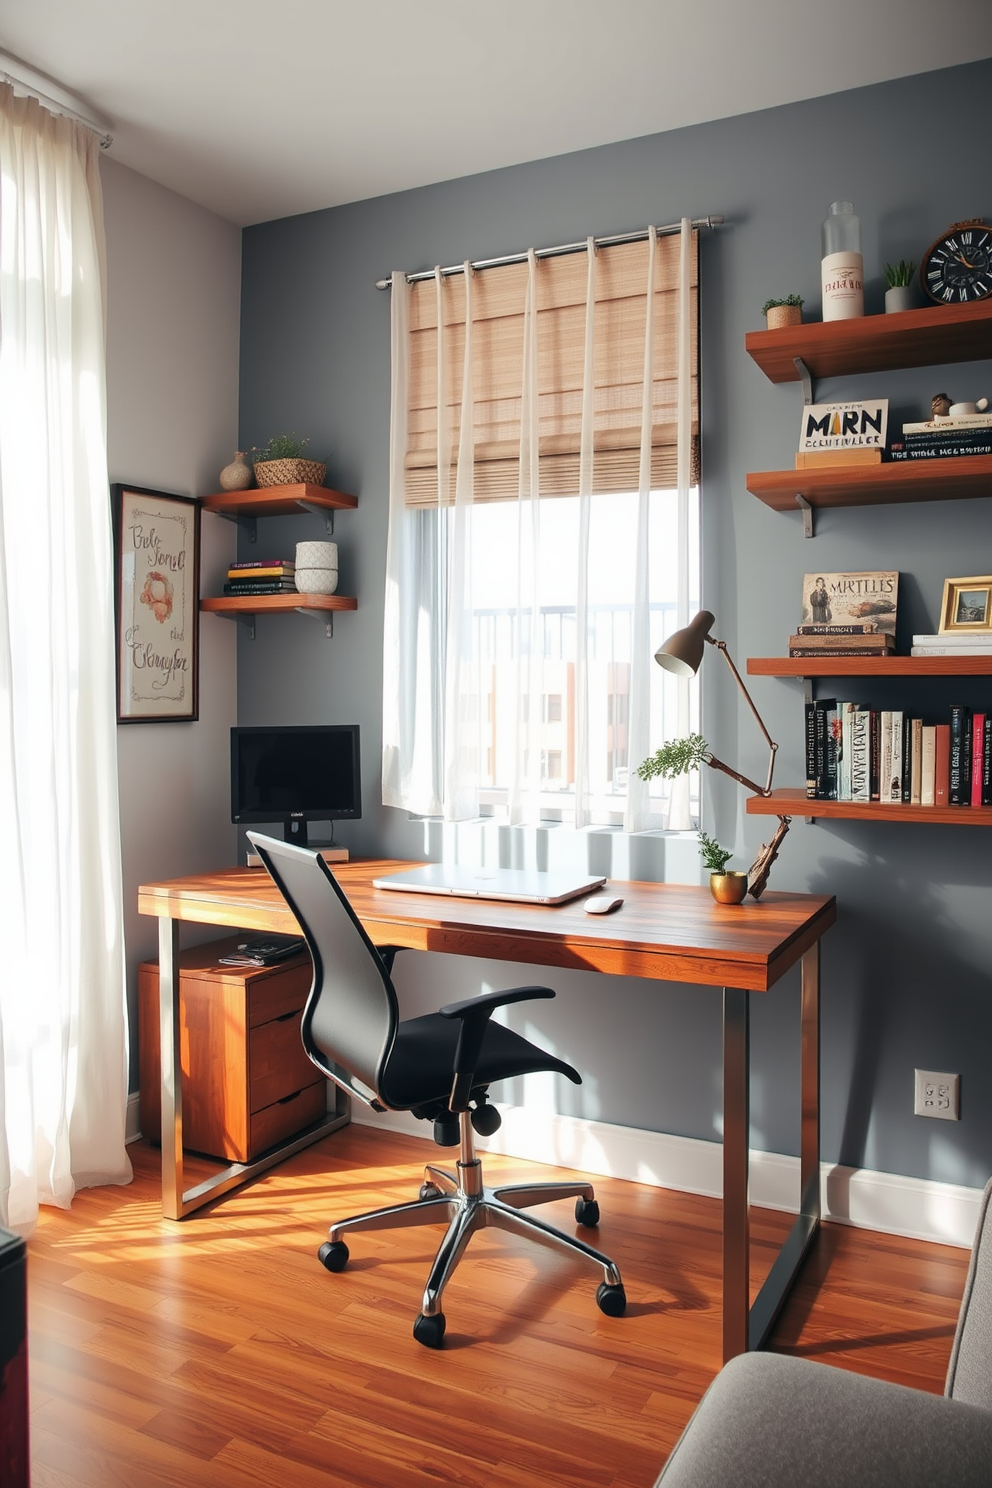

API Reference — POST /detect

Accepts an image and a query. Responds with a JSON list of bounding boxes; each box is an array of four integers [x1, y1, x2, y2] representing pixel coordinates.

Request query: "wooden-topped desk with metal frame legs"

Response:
[[138, 862, 836, 1359]]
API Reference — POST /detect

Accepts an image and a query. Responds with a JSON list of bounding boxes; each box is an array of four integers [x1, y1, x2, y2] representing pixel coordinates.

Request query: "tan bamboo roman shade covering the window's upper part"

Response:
[[405, 232, 699, 506]]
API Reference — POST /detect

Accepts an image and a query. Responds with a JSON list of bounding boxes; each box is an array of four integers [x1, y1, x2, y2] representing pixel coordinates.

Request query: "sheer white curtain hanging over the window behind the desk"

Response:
[[382, 220, 698, 832]]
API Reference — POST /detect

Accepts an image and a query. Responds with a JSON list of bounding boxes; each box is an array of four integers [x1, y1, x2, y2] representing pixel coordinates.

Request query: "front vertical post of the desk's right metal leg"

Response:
[[723, 987, 751, 1363]]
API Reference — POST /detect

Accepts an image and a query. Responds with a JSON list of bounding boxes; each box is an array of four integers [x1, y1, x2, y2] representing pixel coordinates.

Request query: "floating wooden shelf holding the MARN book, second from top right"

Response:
[[747, 449, 992, 512]]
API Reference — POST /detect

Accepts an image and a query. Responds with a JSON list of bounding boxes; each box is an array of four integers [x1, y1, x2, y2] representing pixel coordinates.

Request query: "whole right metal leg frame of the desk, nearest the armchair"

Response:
[[723, 943, 819, 1362]]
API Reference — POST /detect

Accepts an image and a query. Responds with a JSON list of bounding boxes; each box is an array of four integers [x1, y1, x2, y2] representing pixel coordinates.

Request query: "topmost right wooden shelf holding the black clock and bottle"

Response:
[[744, 301, 992, 383]]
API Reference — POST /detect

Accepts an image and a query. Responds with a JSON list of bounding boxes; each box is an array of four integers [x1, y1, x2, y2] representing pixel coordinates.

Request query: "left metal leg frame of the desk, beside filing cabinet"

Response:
[[159, 917, 351, 1219]]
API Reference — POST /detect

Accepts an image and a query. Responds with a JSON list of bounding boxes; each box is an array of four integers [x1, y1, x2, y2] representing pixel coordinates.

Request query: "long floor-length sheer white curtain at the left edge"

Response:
[[0, 85, 131, 1232]]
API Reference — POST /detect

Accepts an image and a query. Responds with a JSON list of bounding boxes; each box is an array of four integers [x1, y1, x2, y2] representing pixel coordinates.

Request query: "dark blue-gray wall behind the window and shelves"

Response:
[[238, 61, 992, 1184]]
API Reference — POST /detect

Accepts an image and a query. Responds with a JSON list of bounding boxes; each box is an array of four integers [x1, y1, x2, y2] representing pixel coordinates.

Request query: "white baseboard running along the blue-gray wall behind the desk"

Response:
[[352, 1101, 982, 1248]]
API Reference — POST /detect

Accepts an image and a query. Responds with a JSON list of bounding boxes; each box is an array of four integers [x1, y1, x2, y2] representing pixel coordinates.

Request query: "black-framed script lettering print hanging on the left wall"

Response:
[[110, 485, 199, 723]]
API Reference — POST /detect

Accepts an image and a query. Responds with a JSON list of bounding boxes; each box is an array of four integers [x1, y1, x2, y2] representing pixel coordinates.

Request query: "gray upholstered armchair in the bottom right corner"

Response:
[[656, 1183, 992, 1488]]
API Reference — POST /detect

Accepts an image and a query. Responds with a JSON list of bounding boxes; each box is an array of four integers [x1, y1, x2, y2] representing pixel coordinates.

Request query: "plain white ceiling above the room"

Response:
[[0, 0, 992, 223]]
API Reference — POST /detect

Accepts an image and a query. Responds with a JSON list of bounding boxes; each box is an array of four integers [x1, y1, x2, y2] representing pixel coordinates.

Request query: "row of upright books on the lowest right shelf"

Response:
[[806, 698, 992, 806]]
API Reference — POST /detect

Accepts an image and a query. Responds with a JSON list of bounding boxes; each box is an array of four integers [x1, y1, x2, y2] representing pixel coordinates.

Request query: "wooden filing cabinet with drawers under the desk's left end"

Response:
[[138, 936, 329, 1162]]
